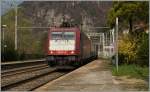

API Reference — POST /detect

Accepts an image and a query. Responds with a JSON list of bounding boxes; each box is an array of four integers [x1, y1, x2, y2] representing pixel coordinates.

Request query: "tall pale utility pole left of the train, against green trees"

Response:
[[15, 4, 18, 50]]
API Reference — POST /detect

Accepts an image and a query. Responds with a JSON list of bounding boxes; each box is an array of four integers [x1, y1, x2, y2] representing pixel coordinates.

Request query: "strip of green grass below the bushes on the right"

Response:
[[112, 64, 149, 79]]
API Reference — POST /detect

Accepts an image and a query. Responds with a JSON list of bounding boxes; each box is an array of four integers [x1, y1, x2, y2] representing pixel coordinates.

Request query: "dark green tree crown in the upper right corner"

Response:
[[107, 1, 149, 33]]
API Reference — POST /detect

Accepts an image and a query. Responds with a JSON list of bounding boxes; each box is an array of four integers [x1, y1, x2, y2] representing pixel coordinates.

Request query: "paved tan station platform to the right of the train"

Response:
[[34, 60, 121, 92]]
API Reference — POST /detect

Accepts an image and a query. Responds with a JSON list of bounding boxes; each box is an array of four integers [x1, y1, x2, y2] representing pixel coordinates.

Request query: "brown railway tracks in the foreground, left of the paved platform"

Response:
[[1, 65, 71, 91]]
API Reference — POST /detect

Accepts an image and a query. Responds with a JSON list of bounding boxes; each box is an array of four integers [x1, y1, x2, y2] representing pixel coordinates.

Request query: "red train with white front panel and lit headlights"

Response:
[[46, 27, 97, 66]]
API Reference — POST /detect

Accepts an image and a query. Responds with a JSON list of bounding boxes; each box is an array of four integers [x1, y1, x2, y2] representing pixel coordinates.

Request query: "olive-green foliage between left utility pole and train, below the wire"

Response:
[[18, 30, 47, 59]]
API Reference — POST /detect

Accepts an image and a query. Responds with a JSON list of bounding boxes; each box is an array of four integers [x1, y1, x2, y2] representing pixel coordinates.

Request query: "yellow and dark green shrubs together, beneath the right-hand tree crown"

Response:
[[118, 32, 149, 66]]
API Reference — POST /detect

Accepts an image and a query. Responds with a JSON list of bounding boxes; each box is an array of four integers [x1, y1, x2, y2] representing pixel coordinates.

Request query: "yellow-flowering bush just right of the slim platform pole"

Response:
[[118, 35, 137, 64]]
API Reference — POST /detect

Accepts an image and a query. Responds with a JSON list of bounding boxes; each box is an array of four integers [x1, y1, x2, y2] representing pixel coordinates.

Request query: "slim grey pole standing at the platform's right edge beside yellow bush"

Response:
[[115, 17, 118, 72]]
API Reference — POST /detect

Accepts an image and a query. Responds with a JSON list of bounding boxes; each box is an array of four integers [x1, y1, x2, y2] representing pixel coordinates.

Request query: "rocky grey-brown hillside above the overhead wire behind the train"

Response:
[[20, 1, 111, 26]]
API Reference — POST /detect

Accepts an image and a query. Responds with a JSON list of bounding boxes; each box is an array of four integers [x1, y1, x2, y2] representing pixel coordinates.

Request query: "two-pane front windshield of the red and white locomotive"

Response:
[[51, 32, 75, 40]]
